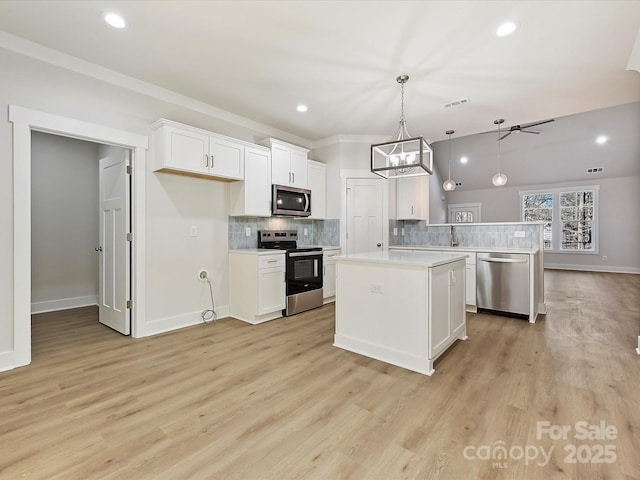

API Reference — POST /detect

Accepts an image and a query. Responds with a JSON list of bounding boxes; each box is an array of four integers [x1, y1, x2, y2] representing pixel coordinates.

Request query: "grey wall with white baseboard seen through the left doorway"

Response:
[[31, 132, 98, 313]]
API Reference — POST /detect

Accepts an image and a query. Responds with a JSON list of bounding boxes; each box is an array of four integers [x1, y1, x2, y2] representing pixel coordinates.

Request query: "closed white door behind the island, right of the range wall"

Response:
[[347, 178, 385, 254]]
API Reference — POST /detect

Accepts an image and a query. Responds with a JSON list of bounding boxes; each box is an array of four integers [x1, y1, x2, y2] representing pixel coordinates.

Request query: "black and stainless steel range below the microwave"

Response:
[[258, 230, 323, 316]]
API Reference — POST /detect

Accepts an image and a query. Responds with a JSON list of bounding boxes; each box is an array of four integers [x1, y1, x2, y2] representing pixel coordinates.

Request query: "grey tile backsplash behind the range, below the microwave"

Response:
[[229, 217, 340, 250]]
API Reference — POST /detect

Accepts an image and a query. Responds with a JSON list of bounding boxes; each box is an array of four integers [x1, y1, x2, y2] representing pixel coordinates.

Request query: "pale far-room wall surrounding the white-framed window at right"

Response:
[[447, 177, 640, 273]]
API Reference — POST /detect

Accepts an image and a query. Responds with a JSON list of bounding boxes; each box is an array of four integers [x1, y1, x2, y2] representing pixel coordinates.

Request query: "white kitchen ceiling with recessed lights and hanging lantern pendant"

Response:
[[0, 0, 640, 187]]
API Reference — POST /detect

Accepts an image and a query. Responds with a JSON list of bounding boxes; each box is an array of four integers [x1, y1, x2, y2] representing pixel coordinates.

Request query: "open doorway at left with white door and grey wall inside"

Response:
[[31, 131, 131, 335]]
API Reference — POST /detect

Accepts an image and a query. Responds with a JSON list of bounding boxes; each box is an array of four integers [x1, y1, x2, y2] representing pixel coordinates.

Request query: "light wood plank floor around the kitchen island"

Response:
[[0, 271, 640, 480]]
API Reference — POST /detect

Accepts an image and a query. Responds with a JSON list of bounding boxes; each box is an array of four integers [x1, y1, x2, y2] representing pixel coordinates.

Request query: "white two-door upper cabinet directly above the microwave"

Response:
[[264, 138, 309, 188]]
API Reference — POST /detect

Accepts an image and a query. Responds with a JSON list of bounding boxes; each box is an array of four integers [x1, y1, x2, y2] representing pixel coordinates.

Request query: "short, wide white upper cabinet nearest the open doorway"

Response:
[[151, 119, 245, 181]]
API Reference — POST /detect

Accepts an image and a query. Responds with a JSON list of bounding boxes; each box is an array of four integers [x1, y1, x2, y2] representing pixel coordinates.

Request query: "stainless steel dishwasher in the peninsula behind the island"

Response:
[[476, 252, 530, 318]]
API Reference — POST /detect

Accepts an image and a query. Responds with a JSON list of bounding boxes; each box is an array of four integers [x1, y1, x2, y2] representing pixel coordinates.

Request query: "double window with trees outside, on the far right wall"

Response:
[[520, 186, 598, 253]]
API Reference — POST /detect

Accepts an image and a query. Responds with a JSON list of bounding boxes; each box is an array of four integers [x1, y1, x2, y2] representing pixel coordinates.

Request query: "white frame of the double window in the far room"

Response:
[[518, 185, 600, 255]]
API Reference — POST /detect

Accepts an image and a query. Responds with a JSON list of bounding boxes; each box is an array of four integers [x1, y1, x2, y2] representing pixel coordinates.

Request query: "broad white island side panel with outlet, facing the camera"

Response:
[[334, 261, 433, 374]]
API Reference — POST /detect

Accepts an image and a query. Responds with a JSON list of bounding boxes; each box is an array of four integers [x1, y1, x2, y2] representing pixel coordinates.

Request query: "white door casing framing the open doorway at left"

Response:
[[8, 105, 149, 368]]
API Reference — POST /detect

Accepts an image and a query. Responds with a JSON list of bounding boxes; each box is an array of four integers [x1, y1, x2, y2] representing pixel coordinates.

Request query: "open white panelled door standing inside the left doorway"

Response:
[[98, 150, 131, 335]]
